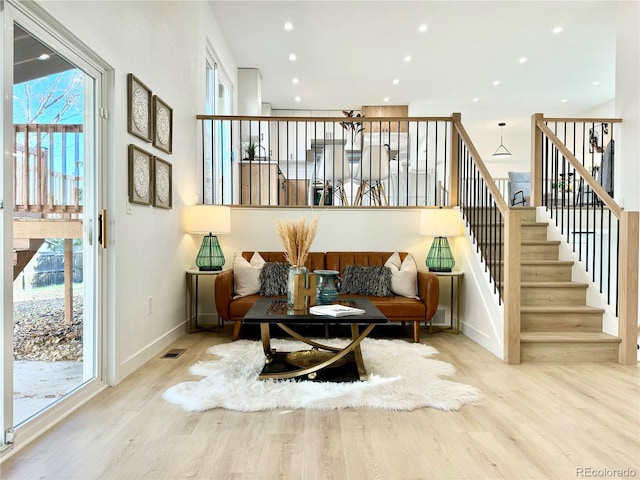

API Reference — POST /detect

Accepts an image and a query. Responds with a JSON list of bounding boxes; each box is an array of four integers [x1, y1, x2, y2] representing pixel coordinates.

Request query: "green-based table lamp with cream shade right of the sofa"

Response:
[[420, 208, 460, 272]]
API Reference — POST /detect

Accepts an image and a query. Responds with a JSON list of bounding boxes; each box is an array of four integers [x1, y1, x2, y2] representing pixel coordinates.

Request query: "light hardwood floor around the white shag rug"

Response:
[[0, 327, 640, 480]]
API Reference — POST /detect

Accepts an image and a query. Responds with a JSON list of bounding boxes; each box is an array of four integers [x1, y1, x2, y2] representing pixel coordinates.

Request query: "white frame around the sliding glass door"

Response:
[[0, 0, 114, 461]]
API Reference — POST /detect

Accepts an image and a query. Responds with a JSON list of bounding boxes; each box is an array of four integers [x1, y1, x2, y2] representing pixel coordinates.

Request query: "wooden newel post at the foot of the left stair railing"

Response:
[[502, 208, 522, 365]]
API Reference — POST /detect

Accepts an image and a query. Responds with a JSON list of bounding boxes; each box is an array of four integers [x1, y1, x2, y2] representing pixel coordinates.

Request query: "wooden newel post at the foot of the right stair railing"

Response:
[[618, 211, 640, 365]]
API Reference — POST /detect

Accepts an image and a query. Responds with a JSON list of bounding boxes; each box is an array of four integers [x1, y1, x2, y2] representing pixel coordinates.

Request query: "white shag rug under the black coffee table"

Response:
[[163, 338, 482, 412]]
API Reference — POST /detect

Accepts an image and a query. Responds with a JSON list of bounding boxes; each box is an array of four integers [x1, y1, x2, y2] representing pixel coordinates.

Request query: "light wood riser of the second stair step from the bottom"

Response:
[[520, 312, 602, 332]]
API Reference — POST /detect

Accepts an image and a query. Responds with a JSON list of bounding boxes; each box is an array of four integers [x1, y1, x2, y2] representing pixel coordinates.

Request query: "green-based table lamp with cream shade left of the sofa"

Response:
[[187, 205, 231, 272]]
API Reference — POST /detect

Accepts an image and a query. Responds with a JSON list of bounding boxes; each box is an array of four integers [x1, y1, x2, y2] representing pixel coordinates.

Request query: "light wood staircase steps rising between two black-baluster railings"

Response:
[[520, 208, 620, 362]]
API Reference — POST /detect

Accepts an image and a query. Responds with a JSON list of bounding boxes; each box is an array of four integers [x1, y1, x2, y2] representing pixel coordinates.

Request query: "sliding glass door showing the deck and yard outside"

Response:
[[2, 3, 101, 452]]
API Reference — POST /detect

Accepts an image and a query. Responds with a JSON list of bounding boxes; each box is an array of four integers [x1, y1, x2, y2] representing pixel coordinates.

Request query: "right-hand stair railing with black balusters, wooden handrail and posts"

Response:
[[531, 114, 638, 364]]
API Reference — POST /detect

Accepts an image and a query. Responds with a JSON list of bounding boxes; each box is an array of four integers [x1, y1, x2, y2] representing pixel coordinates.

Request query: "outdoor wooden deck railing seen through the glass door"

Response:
[[13, 124, 84, 215]]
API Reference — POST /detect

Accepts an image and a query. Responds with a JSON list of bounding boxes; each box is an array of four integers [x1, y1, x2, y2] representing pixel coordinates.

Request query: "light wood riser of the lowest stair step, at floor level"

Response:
[[520, 342, 618, 363]]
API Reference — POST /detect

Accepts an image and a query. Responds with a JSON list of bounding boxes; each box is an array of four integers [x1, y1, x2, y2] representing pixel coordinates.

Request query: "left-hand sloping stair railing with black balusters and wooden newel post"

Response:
[[450, 114, 522, 364]]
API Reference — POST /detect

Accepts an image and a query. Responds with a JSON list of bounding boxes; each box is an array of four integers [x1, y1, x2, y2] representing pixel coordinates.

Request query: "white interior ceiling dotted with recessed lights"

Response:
[[210, 0, 616, 120]]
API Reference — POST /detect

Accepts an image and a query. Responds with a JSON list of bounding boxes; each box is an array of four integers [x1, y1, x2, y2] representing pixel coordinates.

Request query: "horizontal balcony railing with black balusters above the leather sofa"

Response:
[[198, 115, 451, 206]]
